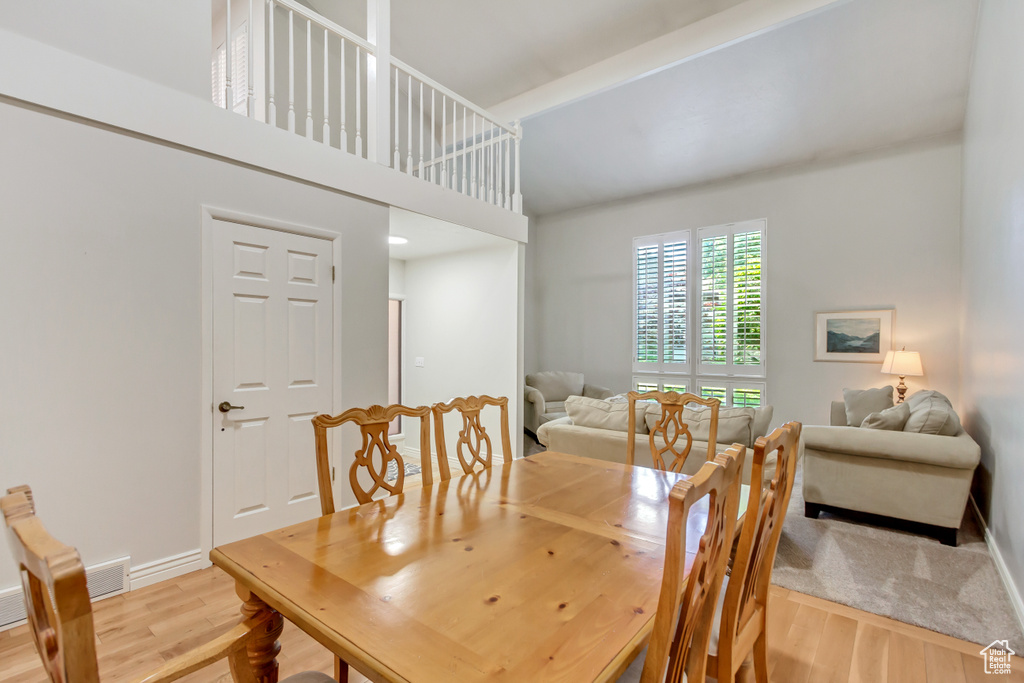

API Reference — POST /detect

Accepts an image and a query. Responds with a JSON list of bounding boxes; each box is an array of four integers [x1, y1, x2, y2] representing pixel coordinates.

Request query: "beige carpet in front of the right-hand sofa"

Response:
[[772, 468, 1024, 652]]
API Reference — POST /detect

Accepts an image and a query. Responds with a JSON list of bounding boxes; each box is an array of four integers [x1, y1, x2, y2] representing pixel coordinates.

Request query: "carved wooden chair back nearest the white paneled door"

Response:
[[312, 403, 433, 515]]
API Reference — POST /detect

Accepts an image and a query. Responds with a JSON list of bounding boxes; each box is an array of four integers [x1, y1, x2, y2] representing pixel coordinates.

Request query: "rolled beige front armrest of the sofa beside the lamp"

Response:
[[802, 425, 981, 470]]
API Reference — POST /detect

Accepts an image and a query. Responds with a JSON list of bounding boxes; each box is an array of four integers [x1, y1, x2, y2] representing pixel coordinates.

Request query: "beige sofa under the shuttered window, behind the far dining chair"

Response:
[[537, 396, 775, 483]]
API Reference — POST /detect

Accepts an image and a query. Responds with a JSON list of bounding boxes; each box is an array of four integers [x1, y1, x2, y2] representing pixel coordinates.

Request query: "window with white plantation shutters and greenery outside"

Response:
[[633, 220, 766, 405]]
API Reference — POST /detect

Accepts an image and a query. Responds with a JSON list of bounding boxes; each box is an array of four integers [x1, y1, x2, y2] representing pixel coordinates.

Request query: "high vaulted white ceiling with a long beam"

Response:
[[307, 0, 978, 216]]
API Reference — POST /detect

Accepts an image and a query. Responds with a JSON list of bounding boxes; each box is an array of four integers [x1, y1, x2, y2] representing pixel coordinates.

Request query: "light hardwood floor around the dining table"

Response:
[[0, 567, 1024, 683]]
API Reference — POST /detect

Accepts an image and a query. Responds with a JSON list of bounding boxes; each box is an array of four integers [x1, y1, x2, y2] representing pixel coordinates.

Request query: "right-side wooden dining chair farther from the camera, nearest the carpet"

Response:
[[708, 422, 802, 683]]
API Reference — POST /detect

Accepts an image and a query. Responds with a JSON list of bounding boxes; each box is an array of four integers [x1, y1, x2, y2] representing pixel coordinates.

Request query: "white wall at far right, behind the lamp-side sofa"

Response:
[[962, 0, 1024, 609]]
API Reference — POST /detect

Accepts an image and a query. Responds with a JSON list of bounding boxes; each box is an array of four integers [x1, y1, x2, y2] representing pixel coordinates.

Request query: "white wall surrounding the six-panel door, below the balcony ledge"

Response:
[[0, 98, 388, 588]]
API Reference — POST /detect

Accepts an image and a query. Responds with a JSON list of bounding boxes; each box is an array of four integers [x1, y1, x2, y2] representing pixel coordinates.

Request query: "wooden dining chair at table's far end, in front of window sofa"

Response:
[[626, 391, 721, 472]]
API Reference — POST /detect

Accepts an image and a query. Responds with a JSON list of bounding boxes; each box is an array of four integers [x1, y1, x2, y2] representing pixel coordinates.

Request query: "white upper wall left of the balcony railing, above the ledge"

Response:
[[0, 0, 209, 98]]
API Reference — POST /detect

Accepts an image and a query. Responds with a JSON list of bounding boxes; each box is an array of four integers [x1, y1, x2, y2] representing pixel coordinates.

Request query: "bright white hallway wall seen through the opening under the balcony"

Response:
[[403, 241, 521, 456]]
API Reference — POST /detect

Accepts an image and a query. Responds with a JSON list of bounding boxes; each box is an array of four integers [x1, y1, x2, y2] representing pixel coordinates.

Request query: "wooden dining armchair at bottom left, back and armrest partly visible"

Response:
[[0, 486, 332, 683]]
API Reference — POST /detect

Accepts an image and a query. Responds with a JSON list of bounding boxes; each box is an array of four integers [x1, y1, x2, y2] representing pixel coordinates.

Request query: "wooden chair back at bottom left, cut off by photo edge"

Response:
[[0, 486, 99, 683]]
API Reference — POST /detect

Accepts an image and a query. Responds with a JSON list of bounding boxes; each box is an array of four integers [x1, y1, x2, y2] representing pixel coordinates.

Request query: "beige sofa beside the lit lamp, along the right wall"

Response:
[[803, 392, 981, 546]]
